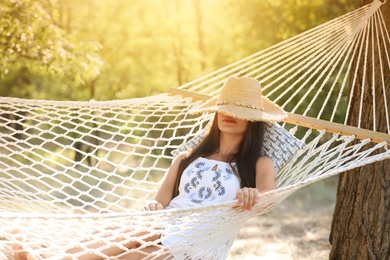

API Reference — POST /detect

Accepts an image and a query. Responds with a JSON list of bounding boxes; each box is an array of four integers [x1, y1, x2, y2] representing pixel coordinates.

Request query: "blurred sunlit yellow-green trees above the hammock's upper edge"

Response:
[[0, 0, 357, 100]]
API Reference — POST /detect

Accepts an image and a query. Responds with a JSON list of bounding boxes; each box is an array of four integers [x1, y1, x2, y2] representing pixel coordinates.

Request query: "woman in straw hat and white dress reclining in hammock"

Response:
[[10, 77, 287, 259]]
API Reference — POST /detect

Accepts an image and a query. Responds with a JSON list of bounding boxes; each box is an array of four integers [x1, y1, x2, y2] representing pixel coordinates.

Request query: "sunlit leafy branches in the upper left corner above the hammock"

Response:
[[0, 0, 101, 100]]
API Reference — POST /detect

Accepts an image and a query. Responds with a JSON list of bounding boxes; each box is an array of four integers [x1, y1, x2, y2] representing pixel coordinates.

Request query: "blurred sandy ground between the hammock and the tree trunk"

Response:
[[228, 177, 338, 260]]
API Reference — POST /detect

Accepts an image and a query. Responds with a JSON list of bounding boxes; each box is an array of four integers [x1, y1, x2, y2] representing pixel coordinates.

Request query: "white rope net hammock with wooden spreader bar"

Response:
[[0, 0, 390, 259]]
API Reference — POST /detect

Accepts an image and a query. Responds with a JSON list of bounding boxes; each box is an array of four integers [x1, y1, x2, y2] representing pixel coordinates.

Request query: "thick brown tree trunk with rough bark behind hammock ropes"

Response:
[[329, 0, 390, 260]]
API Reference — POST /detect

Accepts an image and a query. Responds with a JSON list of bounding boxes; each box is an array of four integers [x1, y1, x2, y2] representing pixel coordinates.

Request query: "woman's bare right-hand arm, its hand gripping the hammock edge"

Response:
[[237, 157, 276, 210]]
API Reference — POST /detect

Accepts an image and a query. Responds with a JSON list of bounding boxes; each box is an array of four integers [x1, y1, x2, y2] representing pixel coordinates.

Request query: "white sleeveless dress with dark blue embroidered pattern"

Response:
[[162, 157, 240, 259]]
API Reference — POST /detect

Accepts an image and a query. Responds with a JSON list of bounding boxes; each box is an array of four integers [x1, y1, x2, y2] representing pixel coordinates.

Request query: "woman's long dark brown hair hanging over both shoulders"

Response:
[[174, 113, 264, 197]]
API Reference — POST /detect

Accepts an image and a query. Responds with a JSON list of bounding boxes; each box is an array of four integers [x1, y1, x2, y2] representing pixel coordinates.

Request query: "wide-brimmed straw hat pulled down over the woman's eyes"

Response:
[[191, 77, 287, 122]]
